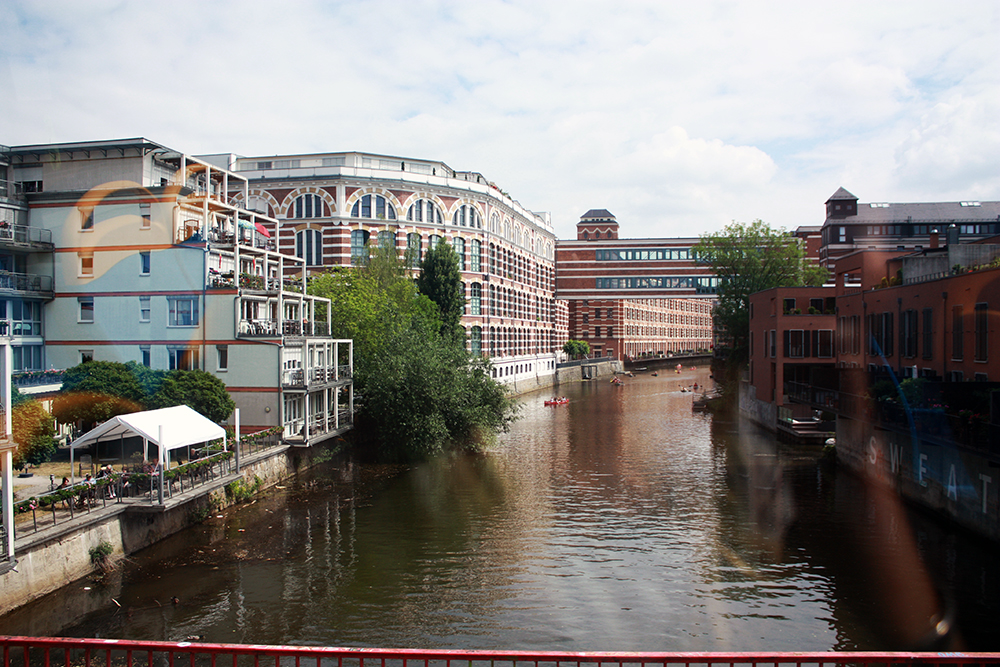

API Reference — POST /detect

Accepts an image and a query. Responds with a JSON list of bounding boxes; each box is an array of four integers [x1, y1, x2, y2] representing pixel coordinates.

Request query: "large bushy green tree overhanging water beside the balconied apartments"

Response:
[[309, 244, 515, 460]]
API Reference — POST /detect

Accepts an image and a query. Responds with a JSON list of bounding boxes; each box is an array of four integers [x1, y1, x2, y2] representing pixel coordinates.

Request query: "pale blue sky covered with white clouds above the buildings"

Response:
[[0, 0, 1000, 238]]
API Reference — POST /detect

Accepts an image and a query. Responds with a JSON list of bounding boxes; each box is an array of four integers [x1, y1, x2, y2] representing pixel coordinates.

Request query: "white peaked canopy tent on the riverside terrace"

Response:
[[70, 405, 226, 481]]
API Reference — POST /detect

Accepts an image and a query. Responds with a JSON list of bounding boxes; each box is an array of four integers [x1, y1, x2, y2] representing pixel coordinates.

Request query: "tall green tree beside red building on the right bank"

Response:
[[694, 220, 827, 367]]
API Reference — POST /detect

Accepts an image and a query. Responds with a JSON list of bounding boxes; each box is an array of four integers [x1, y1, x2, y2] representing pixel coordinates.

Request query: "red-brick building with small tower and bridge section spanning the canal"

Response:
[[556, 209, 718, 360]]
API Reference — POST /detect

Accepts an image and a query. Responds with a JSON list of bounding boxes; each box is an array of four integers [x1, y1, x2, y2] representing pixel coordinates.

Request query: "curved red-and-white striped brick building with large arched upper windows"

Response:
[[203, 152, 567, 381]]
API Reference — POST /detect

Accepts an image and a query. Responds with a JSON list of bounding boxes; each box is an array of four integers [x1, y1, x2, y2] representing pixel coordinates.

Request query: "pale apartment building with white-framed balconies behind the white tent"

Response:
[[0, 139, 353, 445]]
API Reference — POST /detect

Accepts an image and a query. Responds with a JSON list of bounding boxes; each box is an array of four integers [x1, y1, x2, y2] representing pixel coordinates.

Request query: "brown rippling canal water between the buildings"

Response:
[[0, 370, 1000, 651]]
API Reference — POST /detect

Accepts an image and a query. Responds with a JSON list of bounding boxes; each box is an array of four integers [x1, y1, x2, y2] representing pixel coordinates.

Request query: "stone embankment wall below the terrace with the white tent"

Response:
[[0, 446, 312, 614]]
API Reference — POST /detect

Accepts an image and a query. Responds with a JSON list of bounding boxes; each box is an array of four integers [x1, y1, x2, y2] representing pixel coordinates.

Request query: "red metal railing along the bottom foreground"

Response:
[[0, 637, 1000, 667]]
